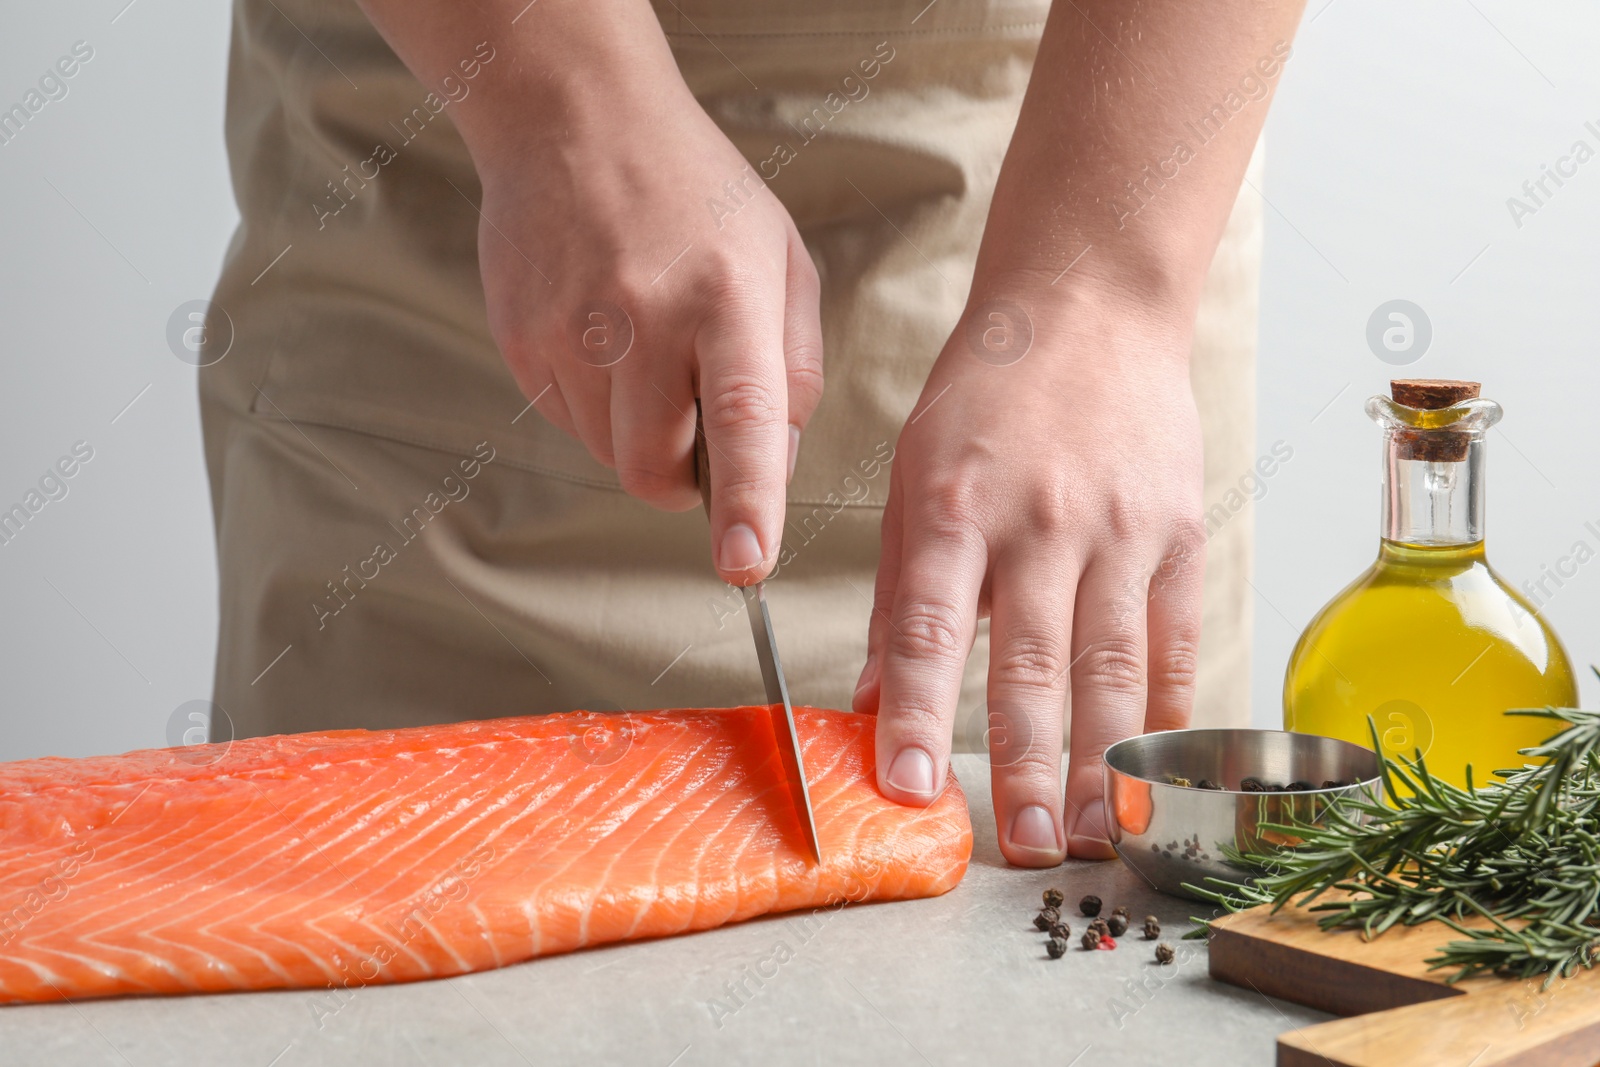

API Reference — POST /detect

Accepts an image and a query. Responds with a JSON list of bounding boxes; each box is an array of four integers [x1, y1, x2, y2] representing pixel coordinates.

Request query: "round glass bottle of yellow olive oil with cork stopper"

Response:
[[1283, 381, 1578, 785]]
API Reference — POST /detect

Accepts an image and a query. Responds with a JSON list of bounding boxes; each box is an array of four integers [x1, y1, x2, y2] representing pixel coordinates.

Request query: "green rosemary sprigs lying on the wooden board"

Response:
[[1186, 669, 1600, 985]]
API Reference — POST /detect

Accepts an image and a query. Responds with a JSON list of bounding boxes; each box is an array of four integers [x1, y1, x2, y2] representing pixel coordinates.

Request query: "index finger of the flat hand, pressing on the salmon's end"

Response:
[[877, 506, 987, 806]]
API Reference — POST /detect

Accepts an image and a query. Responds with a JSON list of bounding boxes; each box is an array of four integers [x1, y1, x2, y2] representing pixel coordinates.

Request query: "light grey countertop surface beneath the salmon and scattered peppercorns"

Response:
[[0, 755, 1328, 1067]]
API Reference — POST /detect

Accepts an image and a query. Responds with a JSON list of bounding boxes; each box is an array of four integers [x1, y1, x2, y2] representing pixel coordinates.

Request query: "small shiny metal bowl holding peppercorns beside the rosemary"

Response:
[[1106, 729, 1382, 899]]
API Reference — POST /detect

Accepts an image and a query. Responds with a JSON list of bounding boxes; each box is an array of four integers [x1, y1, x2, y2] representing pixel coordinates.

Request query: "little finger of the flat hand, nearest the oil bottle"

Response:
[[1144, 526, 1205, 733]]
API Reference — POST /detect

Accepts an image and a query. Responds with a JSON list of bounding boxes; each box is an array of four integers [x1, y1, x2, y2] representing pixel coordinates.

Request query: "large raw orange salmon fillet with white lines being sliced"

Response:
[[0, 707, 973, 1003]]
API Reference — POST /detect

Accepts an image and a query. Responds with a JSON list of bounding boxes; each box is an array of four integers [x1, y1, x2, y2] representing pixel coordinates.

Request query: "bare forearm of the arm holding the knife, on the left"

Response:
[[357, 0, 693, 170]]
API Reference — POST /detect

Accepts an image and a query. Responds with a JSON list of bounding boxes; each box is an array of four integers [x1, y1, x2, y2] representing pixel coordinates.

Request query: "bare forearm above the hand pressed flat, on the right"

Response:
[[973, 0, 1302, 330]]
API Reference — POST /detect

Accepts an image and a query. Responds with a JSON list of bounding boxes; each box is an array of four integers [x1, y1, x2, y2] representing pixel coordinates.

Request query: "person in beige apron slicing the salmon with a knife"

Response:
[[200, 0, 1301, 865]]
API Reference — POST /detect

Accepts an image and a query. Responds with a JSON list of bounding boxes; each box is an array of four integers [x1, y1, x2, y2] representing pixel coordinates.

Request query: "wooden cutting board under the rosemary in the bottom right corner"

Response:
[[1211, 907, 1600, 1067]]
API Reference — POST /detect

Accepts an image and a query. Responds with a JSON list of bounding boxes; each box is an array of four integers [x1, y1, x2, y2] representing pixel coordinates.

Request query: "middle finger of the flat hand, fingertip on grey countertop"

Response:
[[987, 547, 1077, 867]]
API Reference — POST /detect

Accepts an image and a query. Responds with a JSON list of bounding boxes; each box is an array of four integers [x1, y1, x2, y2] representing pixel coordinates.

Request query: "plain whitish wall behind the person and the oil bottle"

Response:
[[0, 0, 1600, 760]]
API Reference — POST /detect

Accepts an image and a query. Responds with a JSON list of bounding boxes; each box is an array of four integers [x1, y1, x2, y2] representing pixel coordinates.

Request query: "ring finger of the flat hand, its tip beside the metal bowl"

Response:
[[1066, 557, 1149, 859]]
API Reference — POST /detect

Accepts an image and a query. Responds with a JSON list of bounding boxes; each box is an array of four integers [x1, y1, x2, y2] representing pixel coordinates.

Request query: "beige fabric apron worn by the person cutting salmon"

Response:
[[200, 0, 1259, 745]]
